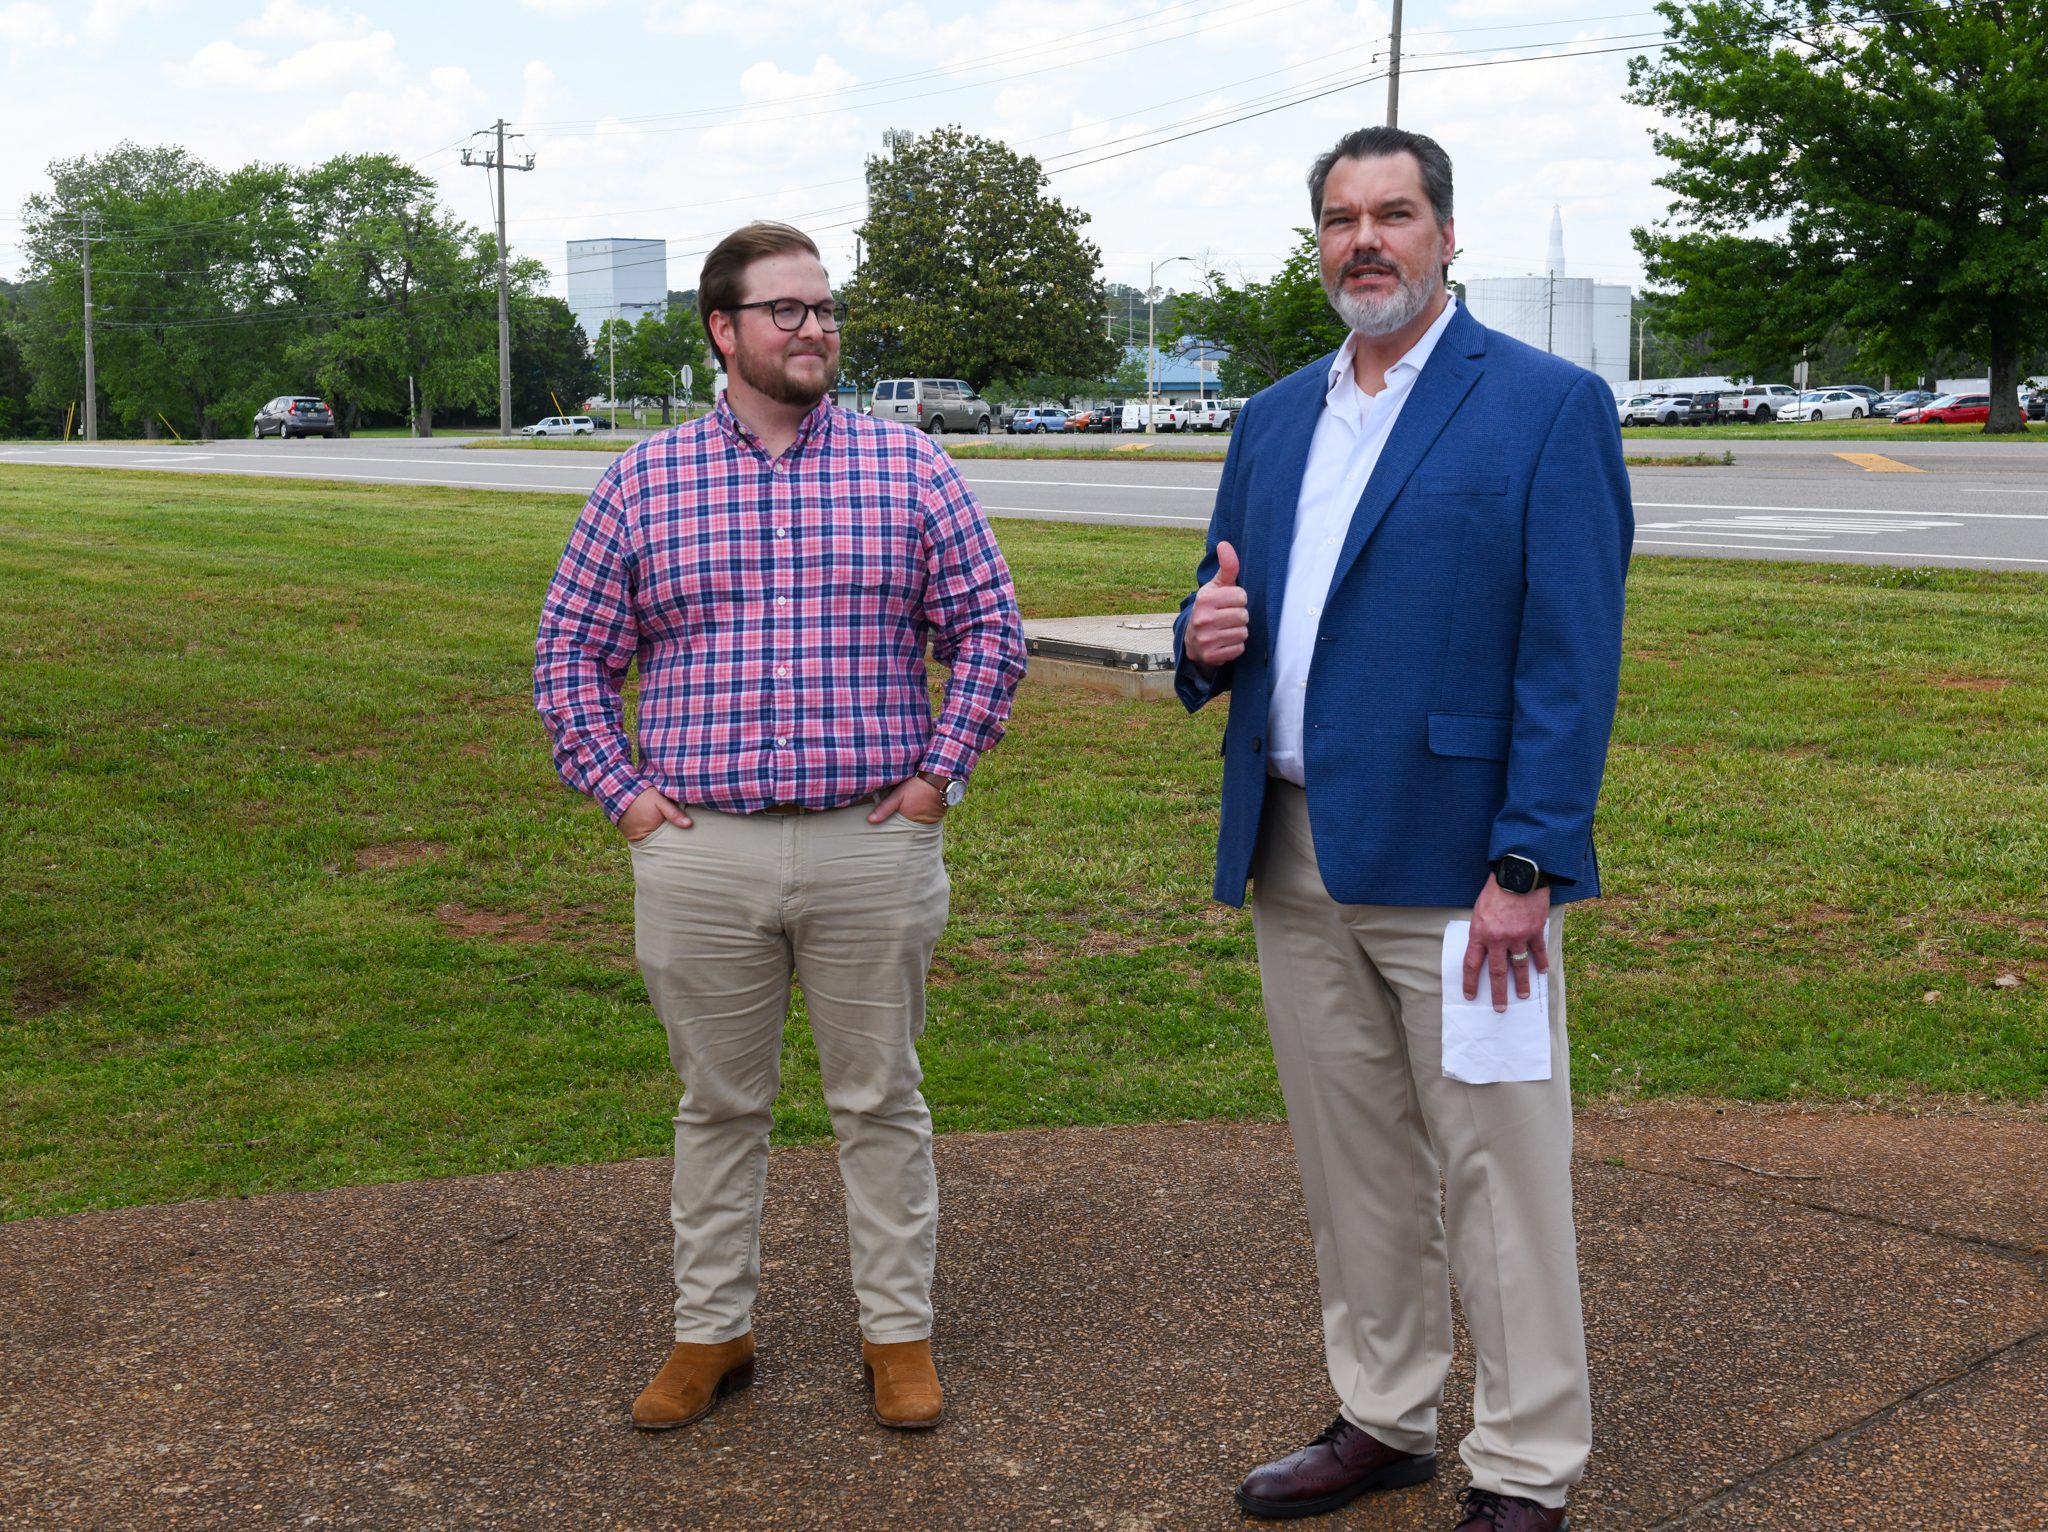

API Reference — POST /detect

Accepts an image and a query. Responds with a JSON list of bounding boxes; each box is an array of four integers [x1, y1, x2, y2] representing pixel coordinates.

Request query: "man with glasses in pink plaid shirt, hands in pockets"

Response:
[[535, 223, 1024, 1430]]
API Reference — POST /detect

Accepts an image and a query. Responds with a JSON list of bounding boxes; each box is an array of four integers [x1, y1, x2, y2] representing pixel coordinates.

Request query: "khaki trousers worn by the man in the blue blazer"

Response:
[[1251, 780, 1593, 1505]]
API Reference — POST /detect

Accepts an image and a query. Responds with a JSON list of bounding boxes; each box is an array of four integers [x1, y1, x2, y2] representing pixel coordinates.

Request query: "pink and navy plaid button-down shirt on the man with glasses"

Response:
[[532, 399, 1024, 819]]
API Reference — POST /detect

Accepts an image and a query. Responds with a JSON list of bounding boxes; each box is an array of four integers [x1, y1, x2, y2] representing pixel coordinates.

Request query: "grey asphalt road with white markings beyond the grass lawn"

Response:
[[12, 438, 2048, 569]]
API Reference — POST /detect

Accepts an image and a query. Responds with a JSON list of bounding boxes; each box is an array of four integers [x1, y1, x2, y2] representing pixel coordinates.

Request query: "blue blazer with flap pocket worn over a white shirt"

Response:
[[1174, 305, 1634, 907]]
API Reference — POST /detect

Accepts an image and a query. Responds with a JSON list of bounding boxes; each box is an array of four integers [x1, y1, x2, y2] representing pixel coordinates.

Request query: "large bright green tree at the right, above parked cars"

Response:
[[1630, 0, 2048, 432]]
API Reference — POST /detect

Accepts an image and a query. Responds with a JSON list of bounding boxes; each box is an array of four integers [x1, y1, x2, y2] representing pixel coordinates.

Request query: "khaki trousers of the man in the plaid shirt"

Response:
[[633, 803, 948, 1346]]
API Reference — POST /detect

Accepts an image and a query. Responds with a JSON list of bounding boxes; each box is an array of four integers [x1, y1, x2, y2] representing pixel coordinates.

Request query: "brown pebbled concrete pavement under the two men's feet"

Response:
[[0, 1106, 2048, 1532]]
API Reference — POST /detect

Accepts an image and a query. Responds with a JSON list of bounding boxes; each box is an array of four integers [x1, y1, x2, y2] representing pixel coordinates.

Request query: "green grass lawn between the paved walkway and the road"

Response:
[[0, 467, 2048, 1217]]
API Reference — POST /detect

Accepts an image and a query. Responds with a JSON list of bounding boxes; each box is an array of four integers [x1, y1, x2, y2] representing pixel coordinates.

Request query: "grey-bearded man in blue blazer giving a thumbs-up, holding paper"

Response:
[[1174, 127, 1634, 1532]]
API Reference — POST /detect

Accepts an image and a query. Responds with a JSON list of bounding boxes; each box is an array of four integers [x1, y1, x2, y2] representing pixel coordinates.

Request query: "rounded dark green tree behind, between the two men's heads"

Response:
[[840, 127, 1116, 389]]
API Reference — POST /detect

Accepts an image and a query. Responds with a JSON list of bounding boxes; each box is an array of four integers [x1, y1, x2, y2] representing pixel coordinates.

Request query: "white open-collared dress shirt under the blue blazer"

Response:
[[1266, 299, 1458, 786]]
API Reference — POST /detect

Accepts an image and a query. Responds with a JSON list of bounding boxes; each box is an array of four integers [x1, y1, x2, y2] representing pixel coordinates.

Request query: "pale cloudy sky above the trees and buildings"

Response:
[[0, 0, 1667, 301]]
